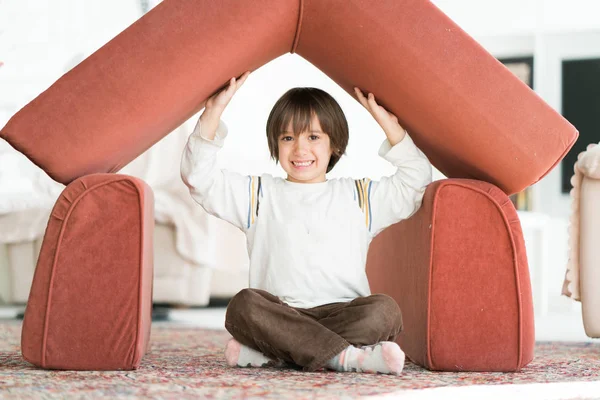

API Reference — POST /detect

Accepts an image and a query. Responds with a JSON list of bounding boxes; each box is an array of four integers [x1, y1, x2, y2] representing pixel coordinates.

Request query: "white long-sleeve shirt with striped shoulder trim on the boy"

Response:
[[181, 117, 431, 308]]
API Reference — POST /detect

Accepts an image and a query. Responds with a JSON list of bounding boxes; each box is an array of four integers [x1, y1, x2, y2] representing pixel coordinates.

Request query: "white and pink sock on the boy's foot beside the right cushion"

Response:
[[326, 342, 405, 375]]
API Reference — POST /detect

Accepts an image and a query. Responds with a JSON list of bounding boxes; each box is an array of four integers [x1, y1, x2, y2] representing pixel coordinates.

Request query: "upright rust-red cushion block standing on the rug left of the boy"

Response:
[[21, 174, 154, 370]]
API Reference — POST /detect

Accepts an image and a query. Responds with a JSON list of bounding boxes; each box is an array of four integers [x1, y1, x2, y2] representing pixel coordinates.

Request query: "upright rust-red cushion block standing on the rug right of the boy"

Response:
[[367, 179, 535, 371]]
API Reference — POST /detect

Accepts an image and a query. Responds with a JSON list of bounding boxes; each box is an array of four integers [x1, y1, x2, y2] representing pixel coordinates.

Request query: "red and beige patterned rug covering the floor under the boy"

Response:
[[0, 322, 600, 399]]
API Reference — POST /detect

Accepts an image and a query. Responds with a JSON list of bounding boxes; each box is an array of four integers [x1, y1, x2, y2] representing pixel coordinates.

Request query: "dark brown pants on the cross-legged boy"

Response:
[[225, 289, 402, 372]]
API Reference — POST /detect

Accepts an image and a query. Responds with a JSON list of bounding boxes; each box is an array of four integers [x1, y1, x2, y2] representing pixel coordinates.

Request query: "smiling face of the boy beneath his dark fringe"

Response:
[[278, 115, 331, 183]]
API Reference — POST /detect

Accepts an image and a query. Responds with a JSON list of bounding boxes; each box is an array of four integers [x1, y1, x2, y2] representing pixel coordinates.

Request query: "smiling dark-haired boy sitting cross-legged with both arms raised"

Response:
[[181, 72, 431, 374]]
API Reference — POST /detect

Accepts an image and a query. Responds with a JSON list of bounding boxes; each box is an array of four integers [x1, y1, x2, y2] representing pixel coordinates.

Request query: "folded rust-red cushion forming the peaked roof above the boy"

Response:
[[0, 0, 577, 193]]
